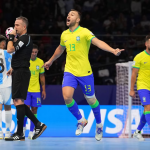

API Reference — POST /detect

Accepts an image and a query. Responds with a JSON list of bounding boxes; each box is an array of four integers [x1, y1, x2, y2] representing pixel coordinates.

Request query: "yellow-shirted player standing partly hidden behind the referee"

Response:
[[23, 44, 46, 139]]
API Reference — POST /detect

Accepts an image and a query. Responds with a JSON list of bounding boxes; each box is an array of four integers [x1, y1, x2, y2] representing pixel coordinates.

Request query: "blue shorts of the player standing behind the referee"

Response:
[[24, 92, 41, 107]]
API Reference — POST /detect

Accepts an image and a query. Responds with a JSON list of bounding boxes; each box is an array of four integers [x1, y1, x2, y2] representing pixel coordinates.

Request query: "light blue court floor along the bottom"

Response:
[[0, 137, 150, 150]]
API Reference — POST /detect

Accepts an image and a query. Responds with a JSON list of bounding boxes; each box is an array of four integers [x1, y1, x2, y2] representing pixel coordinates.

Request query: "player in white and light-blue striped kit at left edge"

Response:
[[0, 35, 12, 139]]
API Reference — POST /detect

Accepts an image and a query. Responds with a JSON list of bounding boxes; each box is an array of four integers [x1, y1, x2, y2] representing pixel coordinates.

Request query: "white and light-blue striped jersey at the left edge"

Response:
[[0, 49, 12, 88]]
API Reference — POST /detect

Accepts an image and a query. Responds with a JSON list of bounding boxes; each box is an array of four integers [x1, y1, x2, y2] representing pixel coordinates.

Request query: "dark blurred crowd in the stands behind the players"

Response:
[[0, 0, 150, 85]]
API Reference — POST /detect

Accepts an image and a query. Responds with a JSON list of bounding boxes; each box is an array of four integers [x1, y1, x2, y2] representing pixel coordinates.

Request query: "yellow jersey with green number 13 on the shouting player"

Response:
[[60, 26, 95, 77]]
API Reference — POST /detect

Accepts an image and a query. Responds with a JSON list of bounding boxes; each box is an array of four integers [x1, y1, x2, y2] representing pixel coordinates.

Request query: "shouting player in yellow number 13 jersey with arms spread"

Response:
[[44, 10, 123, 141]]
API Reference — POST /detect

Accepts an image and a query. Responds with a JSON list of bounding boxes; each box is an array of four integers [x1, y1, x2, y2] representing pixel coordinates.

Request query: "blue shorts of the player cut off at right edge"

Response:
[[138, 89, 150, 106]]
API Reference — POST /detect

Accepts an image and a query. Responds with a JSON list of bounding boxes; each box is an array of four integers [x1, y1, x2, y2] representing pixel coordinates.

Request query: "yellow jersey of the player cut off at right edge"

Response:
[[132, 50, 150, 90]]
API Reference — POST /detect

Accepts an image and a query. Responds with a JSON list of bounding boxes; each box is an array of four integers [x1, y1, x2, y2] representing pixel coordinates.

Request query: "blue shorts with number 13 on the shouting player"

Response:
[[62, 72, 95, 96]]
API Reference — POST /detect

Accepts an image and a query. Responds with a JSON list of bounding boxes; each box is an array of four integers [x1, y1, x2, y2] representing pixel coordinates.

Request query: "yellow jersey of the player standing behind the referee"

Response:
[[28, 57, 45, 92]]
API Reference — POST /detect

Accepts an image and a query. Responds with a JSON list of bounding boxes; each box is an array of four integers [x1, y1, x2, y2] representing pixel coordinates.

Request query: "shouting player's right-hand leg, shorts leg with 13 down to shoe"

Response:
[[77, 74, 103, 140]]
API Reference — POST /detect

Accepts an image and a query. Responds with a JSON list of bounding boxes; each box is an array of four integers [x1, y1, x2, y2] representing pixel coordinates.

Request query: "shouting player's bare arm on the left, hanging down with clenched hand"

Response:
[[43, 45, 65, 70]]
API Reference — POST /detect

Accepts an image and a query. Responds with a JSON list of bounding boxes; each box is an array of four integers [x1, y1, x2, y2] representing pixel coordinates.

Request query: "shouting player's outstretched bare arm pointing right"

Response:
[[92, 38, 124, 56]]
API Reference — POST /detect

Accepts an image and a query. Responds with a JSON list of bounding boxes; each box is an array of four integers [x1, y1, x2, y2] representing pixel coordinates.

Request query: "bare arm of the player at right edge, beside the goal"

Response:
[[129, 68, 139, 98]]
